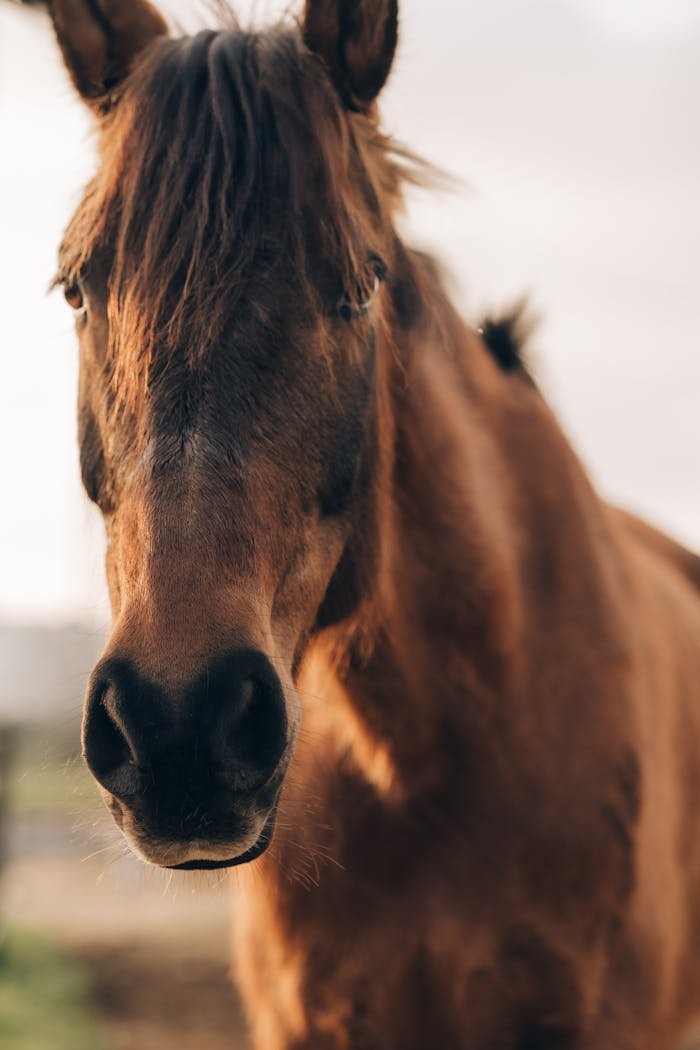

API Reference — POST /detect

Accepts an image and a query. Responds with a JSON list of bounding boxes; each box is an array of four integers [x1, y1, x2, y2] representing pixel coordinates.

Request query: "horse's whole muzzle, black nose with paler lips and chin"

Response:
[[83, 649, 294, 869]]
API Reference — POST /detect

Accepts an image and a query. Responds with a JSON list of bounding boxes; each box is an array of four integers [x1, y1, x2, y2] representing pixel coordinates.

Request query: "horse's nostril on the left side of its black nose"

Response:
[[83, 685, 139, 798]]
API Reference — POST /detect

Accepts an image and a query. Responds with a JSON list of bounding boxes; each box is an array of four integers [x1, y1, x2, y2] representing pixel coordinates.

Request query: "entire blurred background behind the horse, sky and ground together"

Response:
[[0, 0, 700, 1050]]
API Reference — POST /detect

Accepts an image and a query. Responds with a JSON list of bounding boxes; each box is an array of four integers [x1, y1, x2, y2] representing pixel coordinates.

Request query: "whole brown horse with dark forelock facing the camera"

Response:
[[46, 0, 700, 1050]]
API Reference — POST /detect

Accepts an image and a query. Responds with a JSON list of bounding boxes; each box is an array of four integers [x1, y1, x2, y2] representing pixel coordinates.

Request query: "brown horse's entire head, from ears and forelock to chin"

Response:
[[54, 2, 396, 867]]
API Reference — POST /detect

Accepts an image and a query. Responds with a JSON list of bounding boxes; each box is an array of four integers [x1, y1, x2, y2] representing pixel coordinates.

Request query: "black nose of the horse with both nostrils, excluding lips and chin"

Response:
[[83, 650, 288, 799]]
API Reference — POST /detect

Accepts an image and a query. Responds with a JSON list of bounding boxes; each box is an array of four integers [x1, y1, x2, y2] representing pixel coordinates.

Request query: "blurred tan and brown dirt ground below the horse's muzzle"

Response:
[[2, 826, 248, 1050]]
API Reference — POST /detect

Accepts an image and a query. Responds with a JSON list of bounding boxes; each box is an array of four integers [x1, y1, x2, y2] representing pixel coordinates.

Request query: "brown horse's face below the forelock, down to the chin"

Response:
[[78, 254, 384, 866]]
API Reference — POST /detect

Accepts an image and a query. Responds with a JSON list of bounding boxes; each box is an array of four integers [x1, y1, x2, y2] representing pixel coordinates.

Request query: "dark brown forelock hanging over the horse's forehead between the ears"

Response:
[[60, 25, 420, 404]]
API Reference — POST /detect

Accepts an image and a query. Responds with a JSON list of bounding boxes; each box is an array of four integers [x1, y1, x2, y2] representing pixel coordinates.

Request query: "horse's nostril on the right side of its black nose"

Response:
[[225, 675, 287, 791]]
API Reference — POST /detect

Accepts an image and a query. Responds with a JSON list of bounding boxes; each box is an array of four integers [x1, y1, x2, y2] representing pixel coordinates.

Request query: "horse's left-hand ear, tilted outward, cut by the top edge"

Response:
[[49, 0, 168, 112]]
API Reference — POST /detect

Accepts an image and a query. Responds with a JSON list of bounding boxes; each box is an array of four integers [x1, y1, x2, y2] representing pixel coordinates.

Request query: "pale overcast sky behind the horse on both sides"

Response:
[[0, 0, 700, 625]]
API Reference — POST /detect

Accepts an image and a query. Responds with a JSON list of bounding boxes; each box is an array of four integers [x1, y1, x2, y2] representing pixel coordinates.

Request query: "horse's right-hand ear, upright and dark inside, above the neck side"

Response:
[[303, 0, 399, 110]]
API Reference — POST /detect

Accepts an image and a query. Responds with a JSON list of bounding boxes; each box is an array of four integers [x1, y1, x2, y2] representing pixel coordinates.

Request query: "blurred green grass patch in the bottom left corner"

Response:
[[0, 929, 105, 1050]]
